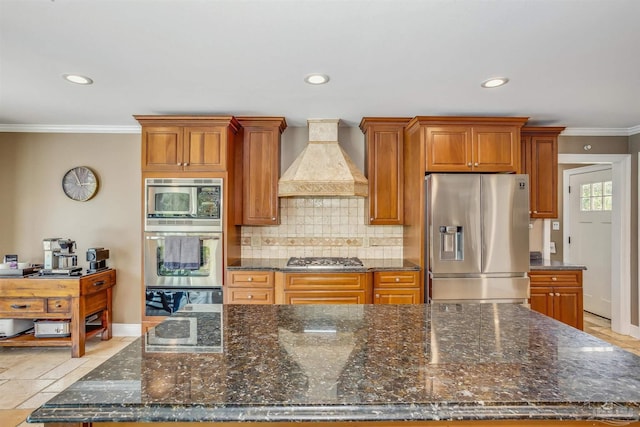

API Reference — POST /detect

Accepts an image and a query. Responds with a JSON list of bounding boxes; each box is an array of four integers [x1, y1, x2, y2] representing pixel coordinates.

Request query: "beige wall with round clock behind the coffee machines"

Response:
[[0, 133, 141, 324]]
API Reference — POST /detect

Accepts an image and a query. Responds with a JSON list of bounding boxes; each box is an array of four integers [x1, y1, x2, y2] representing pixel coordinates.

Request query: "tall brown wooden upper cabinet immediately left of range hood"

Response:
[[237, 117, 287, 225]]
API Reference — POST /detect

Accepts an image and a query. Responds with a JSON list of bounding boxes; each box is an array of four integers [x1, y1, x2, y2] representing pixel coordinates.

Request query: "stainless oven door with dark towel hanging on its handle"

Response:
[[144, 232, 222, 288]]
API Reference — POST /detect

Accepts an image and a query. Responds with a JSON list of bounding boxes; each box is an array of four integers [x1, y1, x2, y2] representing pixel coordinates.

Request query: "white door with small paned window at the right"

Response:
[[565, 165, 613, 319]]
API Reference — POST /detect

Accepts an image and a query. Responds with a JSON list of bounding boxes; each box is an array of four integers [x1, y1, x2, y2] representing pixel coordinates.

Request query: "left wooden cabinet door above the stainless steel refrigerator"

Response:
[[424, 126, 473, 172]]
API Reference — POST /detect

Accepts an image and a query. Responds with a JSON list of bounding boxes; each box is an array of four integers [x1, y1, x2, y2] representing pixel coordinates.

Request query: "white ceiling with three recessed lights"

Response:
[[0, 0, 640, 135]]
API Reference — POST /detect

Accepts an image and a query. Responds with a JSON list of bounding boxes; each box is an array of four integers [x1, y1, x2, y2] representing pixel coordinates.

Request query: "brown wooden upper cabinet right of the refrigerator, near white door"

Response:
[[521, 126, 564, 218]]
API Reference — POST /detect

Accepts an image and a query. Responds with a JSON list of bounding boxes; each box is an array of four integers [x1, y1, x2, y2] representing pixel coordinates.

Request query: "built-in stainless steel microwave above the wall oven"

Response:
[[145, 178, 223, 232]]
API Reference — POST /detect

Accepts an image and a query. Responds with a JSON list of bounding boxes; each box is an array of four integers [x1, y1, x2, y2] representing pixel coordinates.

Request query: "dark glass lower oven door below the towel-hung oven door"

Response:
[[145, 288, 222, 316]]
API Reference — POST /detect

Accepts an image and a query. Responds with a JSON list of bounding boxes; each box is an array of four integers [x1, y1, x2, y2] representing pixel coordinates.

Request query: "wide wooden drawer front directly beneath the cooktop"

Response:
[[282, 273, 371, 304]]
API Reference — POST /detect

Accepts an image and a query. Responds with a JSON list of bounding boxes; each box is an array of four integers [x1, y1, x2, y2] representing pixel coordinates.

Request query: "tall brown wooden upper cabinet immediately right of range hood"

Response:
[[360, 117, 409, 225]]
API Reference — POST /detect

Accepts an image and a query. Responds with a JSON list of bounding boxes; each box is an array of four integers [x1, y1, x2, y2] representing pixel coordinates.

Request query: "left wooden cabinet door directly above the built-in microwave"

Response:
[[142, 126, 183, 171]]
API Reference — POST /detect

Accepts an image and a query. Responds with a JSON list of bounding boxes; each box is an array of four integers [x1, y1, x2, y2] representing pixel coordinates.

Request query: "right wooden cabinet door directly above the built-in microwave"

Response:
[[183, 126, 227, 172]]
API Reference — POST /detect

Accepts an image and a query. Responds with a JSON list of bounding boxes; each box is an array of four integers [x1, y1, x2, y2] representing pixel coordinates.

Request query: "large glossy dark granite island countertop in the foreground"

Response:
[[29, 304, 640, 423]]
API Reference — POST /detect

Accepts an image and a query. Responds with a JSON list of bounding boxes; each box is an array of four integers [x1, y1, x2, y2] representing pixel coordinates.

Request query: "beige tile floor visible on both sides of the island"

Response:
[[0, 312, 640, 427]]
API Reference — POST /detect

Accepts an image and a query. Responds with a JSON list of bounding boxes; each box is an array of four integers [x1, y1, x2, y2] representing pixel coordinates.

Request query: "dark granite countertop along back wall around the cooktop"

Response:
[[227, 258, 420, 273]]
